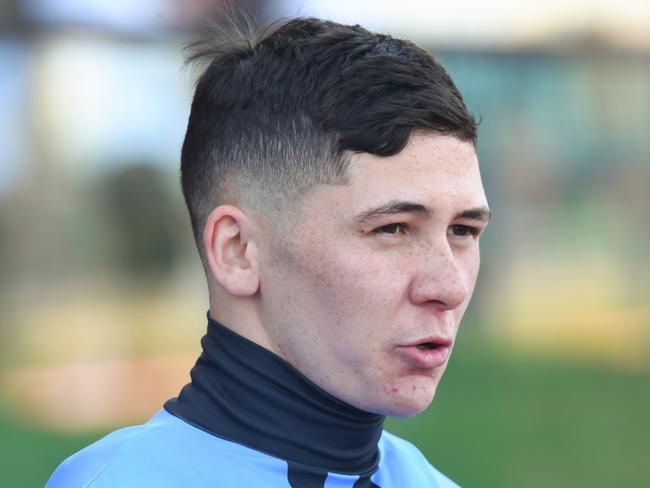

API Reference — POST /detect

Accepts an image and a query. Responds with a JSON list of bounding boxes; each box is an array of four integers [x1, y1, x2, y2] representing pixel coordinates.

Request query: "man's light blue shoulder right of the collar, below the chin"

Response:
[[373, 431, 458, 488]]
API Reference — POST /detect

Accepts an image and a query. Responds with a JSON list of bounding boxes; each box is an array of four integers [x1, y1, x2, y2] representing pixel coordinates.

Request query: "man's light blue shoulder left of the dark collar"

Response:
[[46, 410, 282, 488]]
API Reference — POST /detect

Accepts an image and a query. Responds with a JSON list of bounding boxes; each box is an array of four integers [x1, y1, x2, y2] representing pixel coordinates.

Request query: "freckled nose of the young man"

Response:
[[409, 243, 472, 310]]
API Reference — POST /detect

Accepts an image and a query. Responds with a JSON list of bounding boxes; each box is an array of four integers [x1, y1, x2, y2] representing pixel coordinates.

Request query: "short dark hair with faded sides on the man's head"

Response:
[[181, 18, 476, 254]]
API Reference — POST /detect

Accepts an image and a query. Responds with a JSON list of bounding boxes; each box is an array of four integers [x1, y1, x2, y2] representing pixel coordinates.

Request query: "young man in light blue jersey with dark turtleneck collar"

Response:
[[48, 19, 490, 488]]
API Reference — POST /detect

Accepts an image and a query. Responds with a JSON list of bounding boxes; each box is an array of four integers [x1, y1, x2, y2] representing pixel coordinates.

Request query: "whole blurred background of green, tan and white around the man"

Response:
[[0, 0, 650, 487]]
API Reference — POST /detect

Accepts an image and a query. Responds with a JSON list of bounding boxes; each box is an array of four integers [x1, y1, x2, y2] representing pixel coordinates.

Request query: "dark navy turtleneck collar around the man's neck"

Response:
[[165, 314, 384, 474]]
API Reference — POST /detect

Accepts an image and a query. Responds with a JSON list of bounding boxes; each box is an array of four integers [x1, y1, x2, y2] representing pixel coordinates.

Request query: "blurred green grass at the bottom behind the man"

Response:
[[0, 329, 650, 488]]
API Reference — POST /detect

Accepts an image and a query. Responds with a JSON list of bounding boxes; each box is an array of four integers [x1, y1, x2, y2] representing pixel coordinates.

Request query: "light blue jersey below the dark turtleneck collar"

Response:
[[46, 410, 458, 488]]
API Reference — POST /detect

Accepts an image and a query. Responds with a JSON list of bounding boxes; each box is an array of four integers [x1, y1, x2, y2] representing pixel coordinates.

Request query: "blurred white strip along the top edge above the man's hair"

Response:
[[277, 0, 650, 47]]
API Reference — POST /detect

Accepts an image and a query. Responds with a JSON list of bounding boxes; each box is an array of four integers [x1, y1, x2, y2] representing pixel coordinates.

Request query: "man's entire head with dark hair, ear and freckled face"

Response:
[[182, 19, 489, 415]]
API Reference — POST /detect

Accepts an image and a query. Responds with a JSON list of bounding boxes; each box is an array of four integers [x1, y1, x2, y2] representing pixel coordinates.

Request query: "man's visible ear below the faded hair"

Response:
[[203, 205, 259, 297]]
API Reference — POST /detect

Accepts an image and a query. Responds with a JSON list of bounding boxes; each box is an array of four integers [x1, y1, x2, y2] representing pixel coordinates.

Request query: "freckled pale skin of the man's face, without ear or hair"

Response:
[[251, 134, 489, 417]]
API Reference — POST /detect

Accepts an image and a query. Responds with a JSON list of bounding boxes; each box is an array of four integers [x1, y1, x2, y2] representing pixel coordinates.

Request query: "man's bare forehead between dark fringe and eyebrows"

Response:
[[305, 134, 480, 217]]
